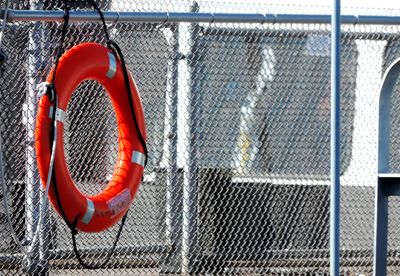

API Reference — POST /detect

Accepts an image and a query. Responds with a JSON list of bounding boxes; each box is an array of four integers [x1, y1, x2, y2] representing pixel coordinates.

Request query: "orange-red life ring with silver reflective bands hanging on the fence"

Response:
[[35, 43, 146, 232]]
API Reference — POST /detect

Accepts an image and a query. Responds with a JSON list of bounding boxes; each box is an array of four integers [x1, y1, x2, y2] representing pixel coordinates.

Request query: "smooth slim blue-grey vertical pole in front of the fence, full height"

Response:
[[330, 0, 341, 276]]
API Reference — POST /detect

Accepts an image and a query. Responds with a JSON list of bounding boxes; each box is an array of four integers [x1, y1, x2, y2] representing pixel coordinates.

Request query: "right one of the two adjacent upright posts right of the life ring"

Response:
[[182, 2, 201, 275]]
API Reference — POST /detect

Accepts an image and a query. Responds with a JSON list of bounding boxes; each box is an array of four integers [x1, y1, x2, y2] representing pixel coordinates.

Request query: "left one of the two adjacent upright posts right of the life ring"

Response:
[[162, 25, 182, 273]]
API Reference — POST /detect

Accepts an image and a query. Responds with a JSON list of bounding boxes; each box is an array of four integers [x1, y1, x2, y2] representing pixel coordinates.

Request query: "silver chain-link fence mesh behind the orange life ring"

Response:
[[0, 0, 400, 276]]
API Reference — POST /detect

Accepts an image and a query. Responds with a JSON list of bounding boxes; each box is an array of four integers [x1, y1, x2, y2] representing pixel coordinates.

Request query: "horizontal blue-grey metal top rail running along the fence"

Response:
[[0, 10, 400, 25]]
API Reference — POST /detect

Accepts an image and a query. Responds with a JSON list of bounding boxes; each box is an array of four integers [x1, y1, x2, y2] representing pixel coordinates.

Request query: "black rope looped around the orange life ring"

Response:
[[44, 0, 147, 269]]
